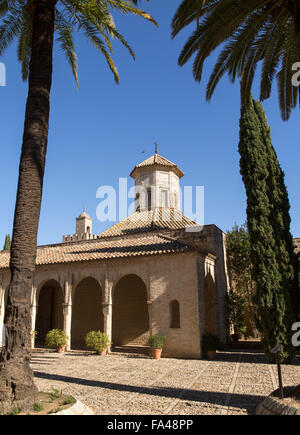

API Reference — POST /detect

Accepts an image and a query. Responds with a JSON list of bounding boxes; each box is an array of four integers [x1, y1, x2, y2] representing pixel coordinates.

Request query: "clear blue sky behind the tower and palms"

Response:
[[0, 0, 300, 247]]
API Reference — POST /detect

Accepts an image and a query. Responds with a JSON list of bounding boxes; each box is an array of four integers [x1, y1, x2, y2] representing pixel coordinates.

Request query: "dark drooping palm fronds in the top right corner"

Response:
[[172, 0, 300, 120]]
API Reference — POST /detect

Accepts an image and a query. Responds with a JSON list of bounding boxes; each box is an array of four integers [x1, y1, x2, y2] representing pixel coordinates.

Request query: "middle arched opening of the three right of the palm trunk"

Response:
[[71, 277, 104, 349]]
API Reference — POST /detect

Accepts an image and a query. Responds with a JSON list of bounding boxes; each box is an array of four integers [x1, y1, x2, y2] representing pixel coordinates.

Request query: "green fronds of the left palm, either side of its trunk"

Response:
[[0, 0, 157, 86]]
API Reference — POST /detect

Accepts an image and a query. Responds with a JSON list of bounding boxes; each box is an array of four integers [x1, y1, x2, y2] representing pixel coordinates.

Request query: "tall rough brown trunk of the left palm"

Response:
[[0, 0, 55, 414]]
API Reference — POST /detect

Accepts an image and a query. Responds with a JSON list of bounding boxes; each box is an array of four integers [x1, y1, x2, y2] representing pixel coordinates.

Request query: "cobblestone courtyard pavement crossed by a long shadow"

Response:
[[31, 350, 300, 415]]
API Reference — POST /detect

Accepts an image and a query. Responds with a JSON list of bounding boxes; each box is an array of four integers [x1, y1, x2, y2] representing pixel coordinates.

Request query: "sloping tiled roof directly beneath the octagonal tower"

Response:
[[99, 208, 199, 237]]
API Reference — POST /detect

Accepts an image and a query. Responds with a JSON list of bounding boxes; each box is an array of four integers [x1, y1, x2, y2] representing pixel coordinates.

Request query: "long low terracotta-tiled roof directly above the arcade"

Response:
[[0, 233, 193, 269]]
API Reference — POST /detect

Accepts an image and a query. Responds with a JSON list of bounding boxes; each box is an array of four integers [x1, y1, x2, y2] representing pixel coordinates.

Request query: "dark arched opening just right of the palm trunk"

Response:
[[35, 279, 64, 346]]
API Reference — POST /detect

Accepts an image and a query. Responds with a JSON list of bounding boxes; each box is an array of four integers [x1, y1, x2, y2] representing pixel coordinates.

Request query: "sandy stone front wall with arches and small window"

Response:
[[0, 252, 205, 358]]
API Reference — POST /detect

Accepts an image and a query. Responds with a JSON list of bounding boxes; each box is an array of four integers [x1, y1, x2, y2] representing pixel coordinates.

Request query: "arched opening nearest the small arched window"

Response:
[[112, 274, 150, 346]]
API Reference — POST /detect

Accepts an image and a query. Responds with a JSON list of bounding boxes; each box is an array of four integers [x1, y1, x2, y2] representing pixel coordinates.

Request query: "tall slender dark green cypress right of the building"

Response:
[[239, 101, 297, 360]]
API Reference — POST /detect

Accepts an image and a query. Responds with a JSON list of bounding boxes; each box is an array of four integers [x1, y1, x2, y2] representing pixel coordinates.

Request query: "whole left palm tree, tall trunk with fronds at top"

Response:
[[0, 0, 156, 413]]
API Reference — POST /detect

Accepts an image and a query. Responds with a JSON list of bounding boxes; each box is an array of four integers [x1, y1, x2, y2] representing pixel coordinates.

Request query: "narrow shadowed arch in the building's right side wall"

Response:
[[204, 272, 217, 334]]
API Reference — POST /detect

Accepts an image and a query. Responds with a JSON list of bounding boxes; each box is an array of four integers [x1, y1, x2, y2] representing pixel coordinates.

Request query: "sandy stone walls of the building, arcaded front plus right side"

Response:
[[0, 225, 228, 358]]
